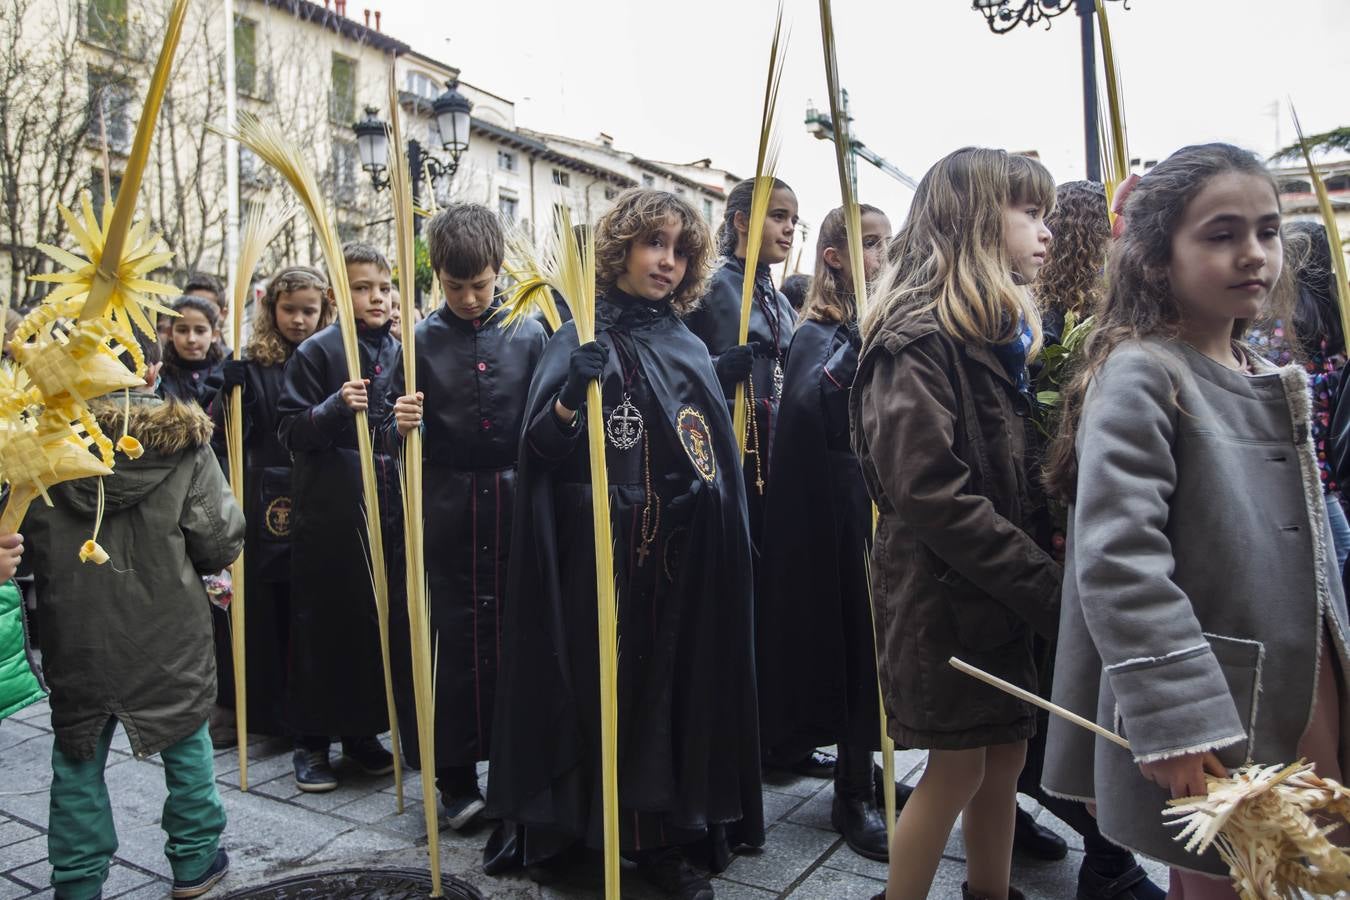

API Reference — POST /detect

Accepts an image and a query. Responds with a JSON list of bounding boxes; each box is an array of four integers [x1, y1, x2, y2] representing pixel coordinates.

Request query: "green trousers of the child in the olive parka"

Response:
[[47, 719, 225, 900]]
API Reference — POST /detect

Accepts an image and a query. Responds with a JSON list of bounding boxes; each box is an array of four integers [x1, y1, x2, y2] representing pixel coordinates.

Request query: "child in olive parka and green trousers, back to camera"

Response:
[[23, 335, 244, 900]]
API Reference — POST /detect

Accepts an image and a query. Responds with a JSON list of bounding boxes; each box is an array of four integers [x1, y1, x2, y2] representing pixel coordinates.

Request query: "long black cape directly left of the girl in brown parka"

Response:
[[755, 321, 880, 760]]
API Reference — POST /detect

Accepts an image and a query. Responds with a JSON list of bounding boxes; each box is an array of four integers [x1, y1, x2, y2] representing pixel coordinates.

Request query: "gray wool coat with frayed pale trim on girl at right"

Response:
[[1044, 340, 1350, 874]]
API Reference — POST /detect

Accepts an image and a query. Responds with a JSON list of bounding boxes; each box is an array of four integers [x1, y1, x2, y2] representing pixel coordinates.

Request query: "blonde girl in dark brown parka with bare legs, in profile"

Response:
[[851, 148, 1060, 900]]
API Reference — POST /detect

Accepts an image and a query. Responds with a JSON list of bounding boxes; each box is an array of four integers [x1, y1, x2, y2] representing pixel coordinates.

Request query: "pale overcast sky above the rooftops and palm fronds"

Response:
[[373, 0, 1350, 269]]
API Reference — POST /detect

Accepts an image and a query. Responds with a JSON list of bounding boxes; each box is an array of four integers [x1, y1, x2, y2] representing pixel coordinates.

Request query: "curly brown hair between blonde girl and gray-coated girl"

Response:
[[1034, 181, 1111, 318]]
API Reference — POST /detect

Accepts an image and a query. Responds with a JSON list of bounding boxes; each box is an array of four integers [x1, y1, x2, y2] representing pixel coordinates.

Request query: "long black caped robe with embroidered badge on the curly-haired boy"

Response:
[[485, 291, 764, 872]]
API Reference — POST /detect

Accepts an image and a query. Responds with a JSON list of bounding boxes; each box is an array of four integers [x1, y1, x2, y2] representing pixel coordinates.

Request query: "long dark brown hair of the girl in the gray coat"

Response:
[[1045, 143, 1295, 502]]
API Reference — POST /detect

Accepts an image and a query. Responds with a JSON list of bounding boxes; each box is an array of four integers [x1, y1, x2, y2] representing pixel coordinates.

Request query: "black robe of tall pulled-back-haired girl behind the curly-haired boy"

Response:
[[687, 256, 797, 555]]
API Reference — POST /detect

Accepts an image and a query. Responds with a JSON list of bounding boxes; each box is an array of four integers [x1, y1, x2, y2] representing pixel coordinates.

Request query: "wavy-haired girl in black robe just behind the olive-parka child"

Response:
[[211, 266, 333, 735]]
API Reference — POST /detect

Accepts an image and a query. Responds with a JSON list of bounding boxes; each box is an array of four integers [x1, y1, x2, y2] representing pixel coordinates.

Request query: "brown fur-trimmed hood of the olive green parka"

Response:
[[53, 393, 212, 514]]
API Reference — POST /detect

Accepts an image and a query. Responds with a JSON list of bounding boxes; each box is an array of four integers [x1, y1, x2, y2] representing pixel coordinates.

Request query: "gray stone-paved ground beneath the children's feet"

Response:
[[0, 703, 1166, 900]]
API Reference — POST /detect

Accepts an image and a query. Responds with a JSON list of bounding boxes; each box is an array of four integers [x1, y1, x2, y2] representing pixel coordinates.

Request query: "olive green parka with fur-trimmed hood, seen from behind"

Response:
[[23, 393, 244, 760]]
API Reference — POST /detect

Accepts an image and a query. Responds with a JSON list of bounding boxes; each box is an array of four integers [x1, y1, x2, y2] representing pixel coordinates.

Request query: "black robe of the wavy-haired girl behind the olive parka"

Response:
[[209, 360, 293, 734]]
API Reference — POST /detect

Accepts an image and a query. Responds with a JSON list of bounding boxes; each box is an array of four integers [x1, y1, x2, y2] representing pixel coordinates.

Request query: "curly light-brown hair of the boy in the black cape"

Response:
[[595, 188, 713, 317]]
